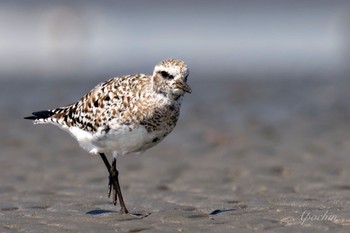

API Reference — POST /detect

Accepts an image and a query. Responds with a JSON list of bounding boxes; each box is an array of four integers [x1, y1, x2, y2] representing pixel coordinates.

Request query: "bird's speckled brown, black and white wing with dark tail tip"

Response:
[[26, 75, 147, 132]]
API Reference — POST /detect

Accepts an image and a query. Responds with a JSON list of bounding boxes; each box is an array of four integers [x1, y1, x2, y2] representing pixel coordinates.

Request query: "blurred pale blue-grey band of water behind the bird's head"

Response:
[[0, 0, 350, 79]]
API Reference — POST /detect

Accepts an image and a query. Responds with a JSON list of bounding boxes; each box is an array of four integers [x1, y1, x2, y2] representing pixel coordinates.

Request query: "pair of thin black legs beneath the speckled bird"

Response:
[[100, 153, 129, 214]]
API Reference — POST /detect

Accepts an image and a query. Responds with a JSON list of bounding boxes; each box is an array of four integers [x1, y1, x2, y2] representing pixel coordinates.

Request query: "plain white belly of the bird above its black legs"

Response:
[[68, 126, 163, 155]]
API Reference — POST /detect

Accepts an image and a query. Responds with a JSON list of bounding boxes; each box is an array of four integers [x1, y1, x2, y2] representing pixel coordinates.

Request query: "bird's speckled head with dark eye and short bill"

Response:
[[152, 59, 192, 96]]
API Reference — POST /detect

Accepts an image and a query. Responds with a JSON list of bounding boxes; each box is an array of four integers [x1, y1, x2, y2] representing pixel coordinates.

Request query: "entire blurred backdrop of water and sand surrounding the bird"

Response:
[[0, 0, 350, 232]]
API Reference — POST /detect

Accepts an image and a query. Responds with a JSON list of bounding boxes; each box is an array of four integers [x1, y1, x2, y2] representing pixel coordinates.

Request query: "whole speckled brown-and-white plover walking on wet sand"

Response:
[[25, 59, 191, 214]]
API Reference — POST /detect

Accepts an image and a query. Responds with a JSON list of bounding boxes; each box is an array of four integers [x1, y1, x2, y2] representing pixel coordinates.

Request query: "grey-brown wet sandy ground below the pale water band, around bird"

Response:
[[0, 78, 350, 233]]
